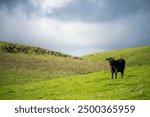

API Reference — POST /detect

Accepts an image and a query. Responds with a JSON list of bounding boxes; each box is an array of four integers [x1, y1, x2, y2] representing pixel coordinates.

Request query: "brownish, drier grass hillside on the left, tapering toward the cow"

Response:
[[0, 42, 105, 85]]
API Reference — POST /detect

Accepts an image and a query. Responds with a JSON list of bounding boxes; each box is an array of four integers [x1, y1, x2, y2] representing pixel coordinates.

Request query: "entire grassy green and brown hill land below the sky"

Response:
[[0, 42, 150, 99]]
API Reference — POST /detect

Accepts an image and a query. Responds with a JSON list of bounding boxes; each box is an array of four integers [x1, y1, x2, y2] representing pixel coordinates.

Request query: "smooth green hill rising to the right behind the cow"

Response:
[[83, 46, 150, 66]]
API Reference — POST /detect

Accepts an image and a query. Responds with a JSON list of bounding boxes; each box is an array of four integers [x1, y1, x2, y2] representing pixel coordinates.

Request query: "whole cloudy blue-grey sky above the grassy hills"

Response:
[[0, 0, 150, 56]]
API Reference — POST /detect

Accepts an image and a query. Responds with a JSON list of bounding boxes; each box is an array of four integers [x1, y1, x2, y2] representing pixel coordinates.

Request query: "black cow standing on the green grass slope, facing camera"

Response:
[[106, 57, 126, 79]]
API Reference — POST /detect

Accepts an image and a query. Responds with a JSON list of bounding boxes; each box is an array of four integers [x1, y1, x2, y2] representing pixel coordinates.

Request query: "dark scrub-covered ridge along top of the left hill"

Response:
[[0, 41, 81, 59]]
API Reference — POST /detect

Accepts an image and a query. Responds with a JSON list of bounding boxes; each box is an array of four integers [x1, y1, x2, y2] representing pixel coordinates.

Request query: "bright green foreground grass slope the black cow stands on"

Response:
[[0, 66, 150, 100]]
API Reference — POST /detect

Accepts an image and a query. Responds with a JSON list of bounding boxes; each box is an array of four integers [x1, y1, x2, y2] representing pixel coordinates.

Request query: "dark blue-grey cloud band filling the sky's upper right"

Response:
[[49, 0, 150, 22]]
